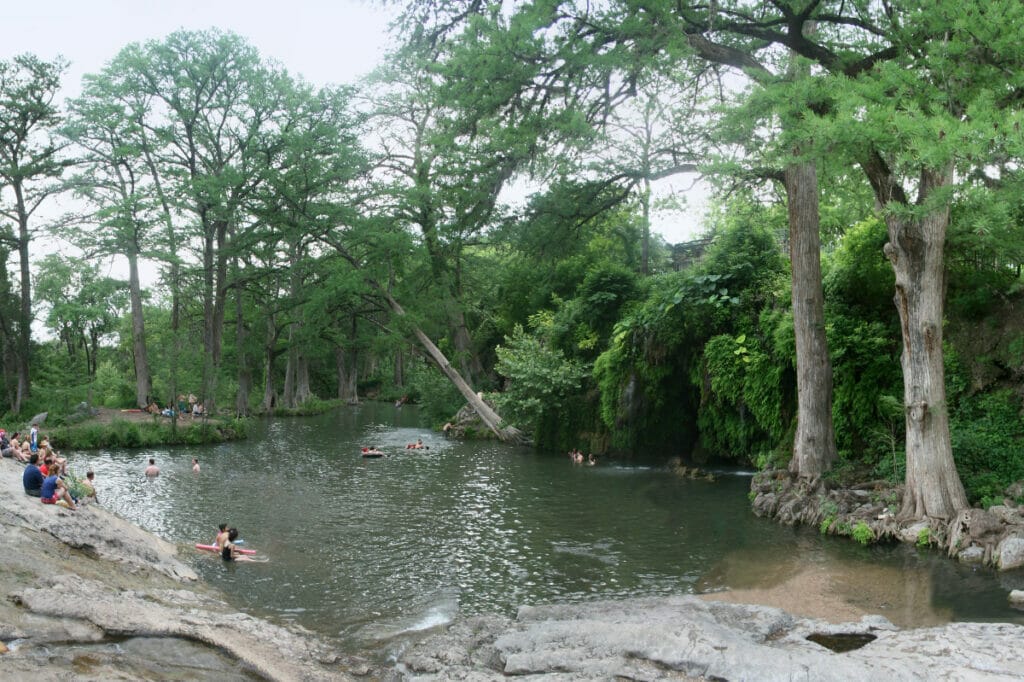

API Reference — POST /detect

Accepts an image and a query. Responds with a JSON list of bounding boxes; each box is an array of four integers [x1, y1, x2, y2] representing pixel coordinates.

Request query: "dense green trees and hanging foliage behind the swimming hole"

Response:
[[0, 1, 1024, 503]]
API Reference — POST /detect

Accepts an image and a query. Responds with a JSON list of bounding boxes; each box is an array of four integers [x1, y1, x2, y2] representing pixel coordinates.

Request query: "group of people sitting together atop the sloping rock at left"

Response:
[[13, 424, 96, 509]]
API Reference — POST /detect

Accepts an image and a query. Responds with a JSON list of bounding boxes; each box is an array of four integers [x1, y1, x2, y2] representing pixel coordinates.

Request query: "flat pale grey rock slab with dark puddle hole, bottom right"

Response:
[[402, 596, 1024, 682]]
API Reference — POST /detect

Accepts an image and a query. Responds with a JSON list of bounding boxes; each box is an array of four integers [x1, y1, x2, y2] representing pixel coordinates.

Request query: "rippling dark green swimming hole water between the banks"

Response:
[[71, 403, 1024, 650]]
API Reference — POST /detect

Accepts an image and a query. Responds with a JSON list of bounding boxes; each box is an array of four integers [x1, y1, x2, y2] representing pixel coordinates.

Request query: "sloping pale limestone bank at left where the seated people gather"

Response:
[[0, 459, 382, 680]]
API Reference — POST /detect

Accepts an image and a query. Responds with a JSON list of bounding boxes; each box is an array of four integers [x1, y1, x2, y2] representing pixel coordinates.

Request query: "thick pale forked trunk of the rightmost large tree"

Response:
[[885, 168, 968, 520]]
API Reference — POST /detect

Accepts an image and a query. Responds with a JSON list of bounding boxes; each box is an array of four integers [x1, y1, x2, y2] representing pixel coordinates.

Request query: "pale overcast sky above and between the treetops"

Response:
[[0, 0, 702, 242]]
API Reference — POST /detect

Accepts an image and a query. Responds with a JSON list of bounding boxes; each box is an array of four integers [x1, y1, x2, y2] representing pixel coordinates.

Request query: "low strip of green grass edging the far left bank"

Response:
[[46, 419, 250, 450]]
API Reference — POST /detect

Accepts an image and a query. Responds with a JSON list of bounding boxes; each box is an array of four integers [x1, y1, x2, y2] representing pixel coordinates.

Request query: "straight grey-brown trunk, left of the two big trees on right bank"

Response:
[[785, 156, 838, 485]]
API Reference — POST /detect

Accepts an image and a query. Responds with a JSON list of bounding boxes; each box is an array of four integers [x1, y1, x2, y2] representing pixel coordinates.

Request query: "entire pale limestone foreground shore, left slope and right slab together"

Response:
[[0, 450, 1024, 681]]
